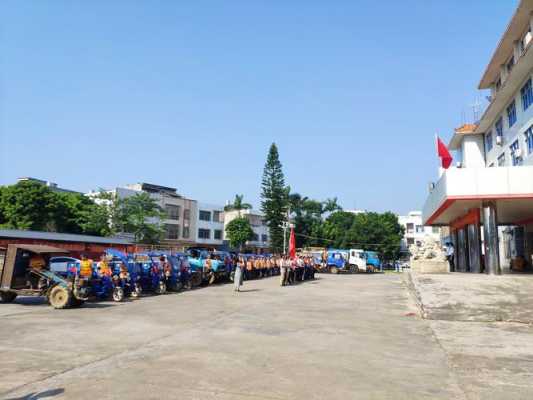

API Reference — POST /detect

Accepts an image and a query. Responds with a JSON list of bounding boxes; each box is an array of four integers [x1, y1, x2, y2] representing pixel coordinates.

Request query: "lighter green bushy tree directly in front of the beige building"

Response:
[[117, 192, 165, 244]]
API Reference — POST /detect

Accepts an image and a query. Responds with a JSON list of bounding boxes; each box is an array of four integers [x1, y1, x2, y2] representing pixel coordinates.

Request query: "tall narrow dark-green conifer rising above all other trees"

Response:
[[261, 143, 288, 253]]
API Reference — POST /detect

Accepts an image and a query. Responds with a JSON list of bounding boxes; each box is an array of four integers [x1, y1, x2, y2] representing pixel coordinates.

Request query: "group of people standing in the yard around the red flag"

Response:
[[233, 255, 315, 292]]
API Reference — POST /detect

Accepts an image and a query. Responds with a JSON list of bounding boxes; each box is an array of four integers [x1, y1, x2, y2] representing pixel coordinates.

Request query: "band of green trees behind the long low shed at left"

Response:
[[0, 181, 163, 243]]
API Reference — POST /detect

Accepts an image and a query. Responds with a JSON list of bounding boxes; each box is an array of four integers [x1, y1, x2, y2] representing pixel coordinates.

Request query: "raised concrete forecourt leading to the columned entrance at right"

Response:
[[405, 273, 533, 399]]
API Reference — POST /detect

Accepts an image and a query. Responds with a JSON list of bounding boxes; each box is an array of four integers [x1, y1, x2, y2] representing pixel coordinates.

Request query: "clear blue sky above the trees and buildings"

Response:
[[0, 0, 517, 213]]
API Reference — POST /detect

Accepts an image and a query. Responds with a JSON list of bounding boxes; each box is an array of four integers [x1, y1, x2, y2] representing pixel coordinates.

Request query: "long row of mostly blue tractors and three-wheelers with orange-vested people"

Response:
[[0, 244, 280, 309]]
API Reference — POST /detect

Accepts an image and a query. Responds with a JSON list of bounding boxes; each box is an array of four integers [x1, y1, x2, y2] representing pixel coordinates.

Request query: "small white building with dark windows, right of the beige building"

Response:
[[196, 203, 224, 248]]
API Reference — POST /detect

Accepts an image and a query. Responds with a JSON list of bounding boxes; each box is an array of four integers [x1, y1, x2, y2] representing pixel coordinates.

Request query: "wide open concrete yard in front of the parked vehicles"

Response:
[[0, 274, 533, 400]]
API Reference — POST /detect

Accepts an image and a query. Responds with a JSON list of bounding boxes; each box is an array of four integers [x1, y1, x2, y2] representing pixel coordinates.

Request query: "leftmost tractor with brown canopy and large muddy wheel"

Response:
[[0, 244, 89, 309]]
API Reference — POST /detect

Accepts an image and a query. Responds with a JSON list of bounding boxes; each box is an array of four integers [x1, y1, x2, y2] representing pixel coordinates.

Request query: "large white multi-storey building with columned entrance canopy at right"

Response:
[[422, 0, 533, 273]]
